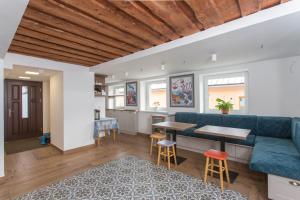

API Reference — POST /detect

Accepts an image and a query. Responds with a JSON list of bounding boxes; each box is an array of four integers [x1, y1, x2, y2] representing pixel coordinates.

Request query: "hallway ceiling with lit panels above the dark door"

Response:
[[4, 65, 58, 81]]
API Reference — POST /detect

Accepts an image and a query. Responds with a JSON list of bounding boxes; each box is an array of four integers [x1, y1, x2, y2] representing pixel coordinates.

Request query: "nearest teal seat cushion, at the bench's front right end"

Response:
[[250, 148, 300, 180]]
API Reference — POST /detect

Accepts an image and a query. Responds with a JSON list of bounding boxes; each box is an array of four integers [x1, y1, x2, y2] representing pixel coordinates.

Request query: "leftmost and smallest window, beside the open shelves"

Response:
[[107, 86, 125, 109]]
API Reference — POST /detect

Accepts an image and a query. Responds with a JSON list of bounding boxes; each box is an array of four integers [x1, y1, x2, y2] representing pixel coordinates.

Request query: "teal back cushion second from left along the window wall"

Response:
[[197, 113, 223, 127]]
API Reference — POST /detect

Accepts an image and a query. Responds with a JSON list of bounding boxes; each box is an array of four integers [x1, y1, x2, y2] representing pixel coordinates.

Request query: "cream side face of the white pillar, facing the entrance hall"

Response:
[[49, 72, 64, 150]]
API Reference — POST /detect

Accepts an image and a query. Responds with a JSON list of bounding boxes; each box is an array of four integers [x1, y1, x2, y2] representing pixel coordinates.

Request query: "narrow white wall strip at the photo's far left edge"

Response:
[[0, 59, 4, 177]]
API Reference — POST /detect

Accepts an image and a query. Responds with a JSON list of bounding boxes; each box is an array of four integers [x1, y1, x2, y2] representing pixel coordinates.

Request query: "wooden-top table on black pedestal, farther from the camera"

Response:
[[152, 121, 197, 165]]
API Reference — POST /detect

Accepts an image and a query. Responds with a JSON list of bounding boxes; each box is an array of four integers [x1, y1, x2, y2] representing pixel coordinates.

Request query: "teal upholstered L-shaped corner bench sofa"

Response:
[[175, 112, 300, 180]]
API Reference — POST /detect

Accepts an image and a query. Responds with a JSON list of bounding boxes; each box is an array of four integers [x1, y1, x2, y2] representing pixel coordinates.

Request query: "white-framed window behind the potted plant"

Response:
[[204, 72, 247, 113]]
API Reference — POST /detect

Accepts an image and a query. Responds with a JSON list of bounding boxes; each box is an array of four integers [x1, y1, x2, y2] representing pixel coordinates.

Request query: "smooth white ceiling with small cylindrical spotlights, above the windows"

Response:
[[93, 1, 300, 81]]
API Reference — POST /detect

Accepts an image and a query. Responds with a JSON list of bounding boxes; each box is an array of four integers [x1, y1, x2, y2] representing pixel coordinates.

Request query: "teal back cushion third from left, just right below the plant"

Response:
[[223, 115, 257, 135]]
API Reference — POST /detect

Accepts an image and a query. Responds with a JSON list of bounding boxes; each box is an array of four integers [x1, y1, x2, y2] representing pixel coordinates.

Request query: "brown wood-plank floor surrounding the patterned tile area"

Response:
[[0, 134, 267, 200]]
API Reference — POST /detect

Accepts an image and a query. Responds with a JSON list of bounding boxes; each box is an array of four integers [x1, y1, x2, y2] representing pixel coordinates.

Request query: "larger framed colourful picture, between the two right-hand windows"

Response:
[[170, 74, 194, 107]]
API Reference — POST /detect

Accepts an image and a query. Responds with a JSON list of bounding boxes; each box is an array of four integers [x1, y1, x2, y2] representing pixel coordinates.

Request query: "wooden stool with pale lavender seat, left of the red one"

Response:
[[157, 140, 177, 169]]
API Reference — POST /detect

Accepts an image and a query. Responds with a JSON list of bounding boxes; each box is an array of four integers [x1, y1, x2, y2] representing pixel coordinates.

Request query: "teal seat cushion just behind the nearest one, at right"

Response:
[[255, 136, 300, 156]]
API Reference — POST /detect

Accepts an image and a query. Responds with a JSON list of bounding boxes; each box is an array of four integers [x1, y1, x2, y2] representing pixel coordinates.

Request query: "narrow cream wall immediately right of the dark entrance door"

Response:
[[43, 80, 50, 133]]
